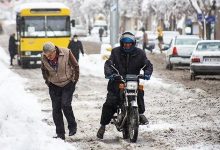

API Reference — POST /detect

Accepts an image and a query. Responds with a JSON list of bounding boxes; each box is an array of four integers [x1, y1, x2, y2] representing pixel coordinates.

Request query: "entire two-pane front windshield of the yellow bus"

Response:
[[21, 16, 70, 37]]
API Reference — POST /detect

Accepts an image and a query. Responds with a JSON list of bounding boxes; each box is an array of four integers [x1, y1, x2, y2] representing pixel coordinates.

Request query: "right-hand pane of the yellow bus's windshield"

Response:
[[46, 16, 70, 37]]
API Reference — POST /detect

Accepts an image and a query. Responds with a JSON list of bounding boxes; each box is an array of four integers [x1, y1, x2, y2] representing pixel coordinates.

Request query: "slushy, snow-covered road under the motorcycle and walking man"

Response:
[[0, 33, 220, 150]]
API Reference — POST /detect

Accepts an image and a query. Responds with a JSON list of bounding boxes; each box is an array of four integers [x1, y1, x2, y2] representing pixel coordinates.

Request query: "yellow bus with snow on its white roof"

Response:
[[16, 2, 75, 68]]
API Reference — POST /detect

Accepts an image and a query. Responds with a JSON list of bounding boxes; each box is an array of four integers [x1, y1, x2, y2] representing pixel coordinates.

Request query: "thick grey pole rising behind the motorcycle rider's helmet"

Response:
[[110, 0, 119, 47]]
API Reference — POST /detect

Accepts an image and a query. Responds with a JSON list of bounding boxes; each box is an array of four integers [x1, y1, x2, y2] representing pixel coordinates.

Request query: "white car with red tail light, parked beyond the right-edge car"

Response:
[[166, 35, 200, 70]]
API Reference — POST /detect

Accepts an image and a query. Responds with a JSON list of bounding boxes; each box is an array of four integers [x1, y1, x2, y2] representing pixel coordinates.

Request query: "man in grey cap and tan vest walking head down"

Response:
[[41, 42, 79, 140]]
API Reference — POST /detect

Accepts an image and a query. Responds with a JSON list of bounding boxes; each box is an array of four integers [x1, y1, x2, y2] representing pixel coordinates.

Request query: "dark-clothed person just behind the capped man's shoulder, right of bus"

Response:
[[68, 35, 84, 62]]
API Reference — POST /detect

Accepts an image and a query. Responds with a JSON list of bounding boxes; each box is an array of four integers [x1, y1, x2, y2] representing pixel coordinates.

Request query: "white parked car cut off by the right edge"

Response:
[[190, 40, 220, 80]]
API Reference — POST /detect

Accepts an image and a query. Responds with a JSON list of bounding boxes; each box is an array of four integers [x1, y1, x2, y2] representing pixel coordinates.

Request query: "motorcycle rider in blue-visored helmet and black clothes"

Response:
[[97, 32, 153, 139]]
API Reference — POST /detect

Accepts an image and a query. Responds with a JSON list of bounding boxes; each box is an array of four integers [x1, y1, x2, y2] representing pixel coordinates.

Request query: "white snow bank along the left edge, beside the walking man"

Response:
[[0, 49, 75, 150]]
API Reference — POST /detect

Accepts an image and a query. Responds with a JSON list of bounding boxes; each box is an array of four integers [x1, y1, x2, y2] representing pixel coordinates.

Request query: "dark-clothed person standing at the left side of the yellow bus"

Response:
[[8, 33, 17, 66]]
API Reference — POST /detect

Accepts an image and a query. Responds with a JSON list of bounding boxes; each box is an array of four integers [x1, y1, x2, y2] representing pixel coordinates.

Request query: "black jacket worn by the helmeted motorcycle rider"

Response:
[[104, 47, 153, 91]]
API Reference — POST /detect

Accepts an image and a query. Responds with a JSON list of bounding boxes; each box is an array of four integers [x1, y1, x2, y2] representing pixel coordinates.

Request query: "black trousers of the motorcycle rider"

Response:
[[100, 91, 145, 125]]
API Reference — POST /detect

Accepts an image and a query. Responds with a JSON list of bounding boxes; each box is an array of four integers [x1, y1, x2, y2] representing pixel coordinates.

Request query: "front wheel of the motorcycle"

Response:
[[128, 107, 139, 143]]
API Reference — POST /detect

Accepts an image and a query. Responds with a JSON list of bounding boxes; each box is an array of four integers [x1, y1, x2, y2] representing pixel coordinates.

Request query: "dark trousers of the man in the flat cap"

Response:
[[49, 81, 76, 134]]
